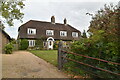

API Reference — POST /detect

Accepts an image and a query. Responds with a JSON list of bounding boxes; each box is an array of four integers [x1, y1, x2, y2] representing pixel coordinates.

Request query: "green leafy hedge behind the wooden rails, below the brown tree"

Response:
[[65, 30, 120, 78]]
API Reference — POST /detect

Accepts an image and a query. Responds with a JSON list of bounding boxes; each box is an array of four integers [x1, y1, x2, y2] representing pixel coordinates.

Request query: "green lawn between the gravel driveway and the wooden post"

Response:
[[30, 50, 57, 66]]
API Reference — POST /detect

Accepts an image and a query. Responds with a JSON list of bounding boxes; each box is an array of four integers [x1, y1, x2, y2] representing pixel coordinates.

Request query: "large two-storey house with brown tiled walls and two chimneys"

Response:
[[18, 16, 81, 49]]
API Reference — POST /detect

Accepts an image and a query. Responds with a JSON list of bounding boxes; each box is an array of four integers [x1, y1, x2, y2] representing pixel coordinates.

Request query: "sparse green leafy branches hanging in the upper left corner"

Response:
[[0, 0, 25, 26]]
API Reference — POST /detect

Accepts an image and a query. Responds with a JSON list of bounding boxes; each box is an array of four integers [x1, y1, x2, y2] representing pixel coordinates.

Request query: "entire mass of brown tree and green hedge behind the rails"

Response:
[[65, 5, 120, 78]]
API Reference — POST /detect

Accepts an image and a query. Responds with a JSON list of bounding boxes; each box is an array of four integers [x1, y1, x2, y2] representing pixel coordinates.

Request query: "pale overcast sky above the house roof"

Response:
[[5, 0, 119, 39]]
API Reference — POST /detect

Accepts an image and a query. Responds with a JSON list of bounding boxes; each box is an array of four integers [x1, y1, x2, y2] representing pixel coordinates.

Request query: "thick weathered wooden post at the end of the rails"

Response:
[[58, 41, 63, 70]]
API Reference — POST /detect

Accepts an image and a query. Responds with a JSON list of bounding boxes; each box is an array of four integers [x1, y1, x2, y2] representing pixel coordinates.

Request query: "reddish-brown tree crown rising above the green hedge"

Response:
[[88, 4, 120, 35]]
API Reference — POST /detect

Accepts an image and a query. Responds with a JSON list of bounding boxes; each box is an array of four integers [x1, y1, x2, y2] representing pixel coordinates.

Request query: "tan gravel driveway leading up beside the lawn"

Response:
[[2, 51, 67, 78]]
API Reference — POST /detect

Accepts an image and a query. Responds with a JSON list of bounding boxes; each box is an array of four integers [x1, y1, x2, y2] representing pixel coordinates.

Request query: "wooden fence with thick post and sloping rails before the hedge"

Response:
[[58, 42, 120, 79]]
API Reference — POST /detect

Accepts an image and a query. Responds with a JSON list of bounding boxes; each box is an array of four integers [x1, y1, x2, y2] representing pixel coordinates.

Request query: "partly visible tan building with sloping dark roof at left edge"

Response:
[[0, 28, 11, 53]]
